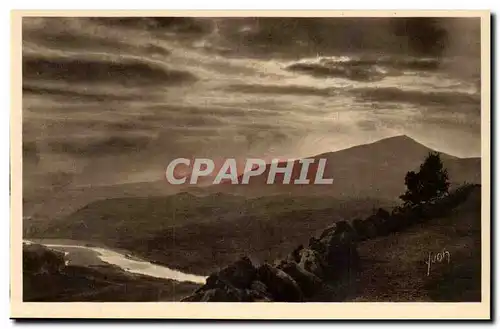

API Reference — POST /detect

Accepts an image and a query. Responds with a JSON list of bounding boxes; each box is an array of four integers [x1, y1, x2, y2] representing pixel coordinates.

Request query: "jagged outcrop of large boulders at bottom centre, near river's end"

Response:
[[184, 221, 359, 302]]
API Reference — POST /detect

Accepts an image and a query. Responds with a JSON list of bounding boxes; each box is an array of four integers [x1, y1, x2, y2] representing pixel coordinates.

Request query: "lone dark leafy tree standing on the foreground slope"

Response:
[[400, 152, 450, 204]]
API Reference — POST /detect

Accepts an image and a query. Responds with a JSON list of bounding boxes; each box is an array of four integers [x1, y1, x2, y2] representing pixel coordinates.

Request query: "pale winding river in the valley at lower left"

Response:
[[24, 240, 206, 284]]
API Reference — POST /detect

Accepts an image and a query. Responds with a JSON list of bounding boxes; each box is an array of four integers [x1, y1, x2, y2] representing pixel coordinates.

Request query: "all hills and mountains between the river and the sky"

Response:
[[24, 137, 481, 275]]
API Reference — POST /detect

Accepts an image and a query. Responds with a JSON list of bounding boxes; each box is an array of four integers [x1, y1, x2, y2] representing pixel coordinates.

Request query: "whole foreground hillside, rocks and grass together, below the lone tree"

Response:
[[183, 185, 481, 302]]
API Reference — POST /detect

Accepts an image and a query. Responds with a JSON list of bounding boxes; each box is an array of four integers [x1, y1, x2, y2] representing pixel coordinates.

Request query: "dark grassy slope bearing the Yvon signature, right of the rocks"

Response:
[[336, 187, 481, 302]]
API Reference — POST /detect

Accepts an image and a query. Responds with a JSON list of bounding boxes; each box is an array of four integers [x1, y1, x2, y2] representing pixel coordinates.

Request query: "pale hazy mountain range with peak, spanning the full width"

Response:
[[25, 136, 481, 218]]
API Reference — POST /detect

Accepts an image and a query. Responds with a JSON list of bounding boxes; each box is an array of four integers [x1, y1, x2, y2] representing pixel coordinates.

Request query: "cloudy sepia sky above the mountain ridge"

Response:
[[23, 17, 480, 192]]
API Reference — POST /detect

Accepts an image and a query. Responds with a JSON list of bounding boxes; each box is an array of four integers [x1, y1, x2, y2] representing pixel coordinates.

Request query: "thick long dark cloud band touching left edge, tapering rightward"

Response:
[[23, 56, 196, 86]]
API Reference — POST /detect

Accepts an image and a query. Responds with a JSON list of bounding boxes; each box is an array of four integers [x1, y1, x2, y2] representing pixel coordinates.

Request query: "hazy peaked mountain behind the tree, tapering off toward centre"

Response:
[[208, 135, 481, 199]]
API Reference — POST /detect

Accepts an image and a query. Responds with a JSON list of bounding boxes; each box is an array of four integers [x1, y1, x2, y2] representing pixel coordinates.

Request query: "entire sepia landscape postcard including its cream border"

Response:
[[11, 11, 491, 319]]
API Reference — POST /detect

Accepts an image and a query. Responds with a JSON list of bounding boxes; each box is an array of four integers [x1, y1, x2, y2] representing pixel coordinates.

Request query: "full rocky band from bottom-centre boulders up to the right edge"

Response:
[[183, 185, 479, 302]]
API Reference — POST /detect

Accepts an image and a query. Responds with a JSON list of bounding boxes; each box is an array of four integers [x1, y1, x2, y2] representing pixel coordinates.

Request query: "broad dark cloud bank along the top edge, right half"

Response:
[[209, 17, 480, 57]]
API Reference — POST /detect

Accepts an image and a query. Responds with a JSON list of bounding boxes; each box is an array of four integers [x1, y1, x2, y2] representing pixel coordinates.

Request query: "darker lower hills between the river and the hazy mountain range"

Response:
[[25, 193, 392, 275]]
